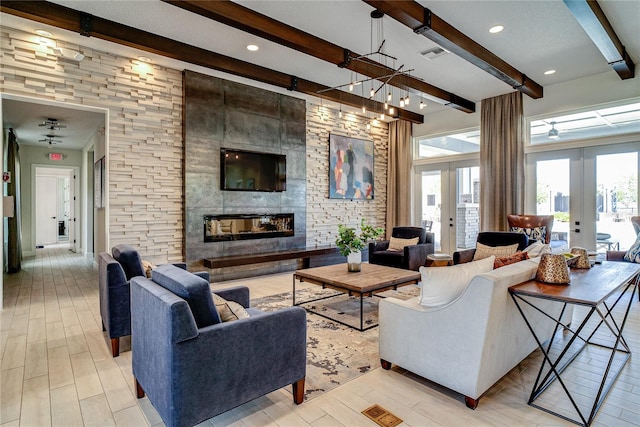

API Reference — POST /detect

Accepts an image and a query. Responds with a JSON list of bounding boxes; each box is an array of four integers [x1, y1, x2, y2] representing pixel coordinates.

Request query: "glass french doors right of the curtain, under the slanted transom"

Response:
[[525, 143, 640, 252]]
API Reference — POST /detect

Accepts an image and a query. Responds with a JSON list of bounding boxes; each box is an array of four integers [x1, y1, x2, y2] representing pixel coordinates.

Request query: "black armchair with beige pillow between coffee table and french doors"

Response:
[[369, 227, 435, 271]]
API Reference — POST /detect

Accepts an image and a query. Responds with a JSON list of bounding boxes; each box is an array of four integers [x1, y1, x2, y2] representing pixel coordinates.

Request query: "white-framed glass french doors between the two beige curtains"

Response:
[[414, 160, 480, 253]]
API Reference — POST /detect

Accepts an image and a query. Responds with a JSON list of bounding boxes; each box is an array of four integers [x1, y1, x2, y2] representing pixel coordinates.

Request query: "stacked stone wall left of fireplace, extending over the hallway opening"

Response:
[[0, 27, 183, 263]]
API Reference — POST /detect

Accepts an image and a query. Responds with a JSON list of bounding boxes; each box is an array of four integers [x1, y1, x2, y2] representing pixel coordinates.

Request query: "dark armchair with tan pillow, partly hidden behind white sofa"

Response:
[[453, 231, 529, 265]]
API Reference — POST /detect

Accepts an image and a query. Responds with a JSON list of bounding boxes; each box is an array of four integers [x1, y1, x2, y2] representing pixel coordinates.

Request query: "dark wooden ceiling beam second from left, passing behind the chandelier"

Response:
[[163, 0, 475, 113]]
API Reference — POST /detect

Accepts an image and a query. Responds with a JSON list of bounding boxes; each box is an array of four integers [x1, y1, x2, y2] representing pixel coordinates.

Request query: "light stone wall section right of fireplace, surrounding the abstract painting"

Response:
[[307, 104, 389, 247]]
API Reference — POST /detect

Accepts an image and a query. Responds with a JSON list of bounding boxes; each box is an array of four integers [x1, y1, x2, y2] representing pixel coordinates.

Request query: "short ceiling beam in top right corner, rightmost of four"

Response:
[[564, 0, 635, 80]]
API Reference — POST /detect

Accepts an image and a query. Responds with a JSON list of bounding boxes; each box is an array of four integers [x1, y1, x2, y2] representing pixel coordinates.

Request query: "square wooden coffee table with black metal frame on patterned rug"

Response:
[[293, 263, 421, 331]]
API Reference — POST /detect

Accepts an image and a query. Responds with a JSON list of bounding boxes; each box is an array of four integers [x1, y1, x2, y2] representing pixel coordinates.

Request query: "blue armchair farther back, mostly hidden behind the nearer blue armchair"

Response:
[[98, 244, 209, 357]]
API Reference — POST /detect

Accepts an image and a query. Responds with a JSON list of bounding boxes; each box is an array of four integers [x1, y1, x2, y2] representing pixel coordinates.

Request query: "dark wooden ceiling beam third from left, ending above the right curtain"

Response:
[[363, 0, 543, 99]]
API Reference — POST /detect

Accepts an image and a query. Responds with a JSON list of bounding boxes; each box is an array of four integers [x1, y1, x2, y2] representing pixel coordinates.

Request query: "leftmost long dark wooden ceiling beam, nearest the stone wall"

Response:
[[0, 0, 424, 123]]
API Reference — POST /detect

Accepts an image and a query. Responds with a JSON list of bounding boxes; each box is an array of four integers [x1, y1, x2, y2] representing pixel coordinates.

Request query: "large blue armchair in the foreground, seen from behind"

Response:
[[131, 265, 306, 427]]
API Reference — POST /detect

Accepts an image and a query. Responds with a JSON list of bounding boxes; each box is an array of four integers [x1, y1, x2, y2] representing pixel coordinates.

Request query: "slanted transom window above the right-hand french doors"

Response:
[[530, 102, 640, 145]]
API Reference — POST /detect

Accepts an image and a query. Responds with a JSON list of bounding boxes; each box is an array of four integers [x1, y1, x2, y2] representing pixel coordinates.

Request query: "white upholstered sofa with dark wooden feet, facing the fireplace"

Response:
[[379, 258, 573, 409]]
